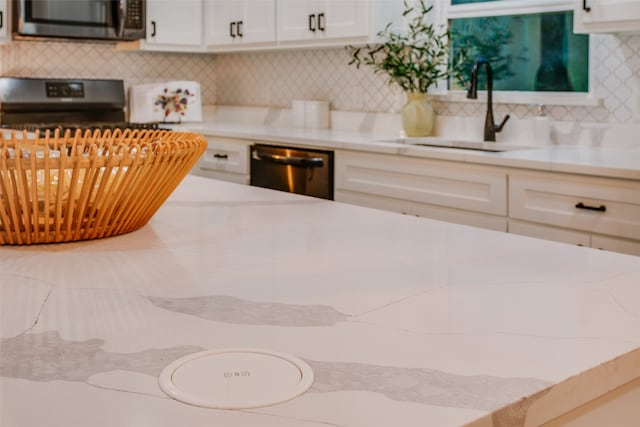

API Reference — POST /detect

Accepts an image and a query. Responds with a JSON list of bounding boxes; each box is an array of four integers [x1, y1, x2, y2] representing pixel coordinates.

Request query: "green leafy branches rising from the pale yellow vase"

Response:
[[347, 0, 464, 93]]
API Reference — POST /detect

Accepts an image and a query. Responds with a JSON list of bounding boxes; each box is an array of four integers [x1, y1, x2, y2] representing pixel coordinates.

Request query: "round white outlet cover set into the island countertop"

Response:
[[158, 348, 313, 409]]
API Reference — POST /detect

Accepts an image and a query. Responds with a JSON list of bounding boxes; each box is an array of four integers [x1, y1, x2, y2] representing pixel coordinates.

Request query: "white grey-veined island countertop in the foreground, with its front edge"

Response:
[[0, 176, 640, 427]]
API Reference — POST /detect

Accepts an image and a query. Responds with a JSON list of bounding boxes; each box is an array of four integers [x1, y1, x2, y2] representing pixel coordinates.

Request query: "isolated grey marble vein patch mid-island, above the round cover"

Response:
[[149, 295, 349, 327]]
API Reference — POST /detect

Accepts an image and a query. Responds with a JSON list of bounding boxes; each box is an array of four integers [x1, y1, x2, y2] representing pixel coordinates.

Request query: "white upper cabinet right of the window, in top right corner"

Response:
[[573, 0, 640, 33]]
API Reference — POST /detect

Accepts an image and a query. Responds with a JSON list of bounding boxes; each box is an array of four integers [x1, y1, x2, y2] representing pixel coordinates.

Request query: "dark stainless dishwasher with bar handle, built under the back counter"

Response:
[[251, 144, 333, 200]]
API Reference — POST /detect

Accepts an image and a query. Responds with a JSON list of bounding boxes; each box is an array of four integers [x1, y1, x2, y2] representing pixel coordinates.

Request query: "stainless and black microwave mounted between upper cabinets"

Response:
[[13, 0, 146, 40]]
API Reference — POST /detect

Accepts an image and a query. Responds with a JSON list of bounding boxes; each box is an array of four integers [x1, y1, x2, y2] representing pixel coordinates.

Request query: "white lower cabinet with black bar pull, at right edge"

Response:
[[509, 172, 640, 255]]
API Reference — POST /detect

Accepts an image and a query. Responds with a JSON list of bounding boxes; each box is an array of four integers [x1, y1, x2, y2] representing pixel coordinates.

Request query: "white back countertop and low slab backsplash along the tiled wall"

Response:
[[169, 107, 640, 180]]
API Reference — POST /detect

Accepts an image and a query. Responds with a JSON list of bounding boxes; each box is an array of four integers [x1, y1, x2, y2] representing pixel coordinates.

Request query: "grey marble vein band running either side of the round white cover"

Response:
[[0, 331, 550, 410]]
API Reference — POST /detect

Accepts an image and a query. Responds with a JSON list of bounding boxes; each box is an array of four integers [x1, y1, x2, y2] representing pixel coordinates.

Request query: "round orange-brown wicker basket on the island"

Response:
[[0, 129, 207, 245]]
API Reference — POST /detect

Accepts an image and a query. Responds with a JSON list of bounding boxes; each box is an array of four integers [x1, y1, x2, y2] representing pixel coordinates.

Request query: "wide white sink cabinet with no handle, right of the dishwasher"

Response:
[[335, 151, 507, 231]]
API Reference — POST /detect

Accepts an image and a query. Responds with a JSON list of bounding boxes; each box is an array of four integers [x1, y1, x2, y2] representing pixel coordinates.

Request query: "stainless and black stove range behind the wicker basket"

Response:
[[0, 77, 158, 134]]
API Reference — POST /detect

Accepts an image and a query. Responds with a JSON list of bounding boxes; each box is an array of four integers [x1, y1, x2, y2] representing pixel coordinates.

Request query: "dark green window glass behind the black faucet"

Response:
[[450, 11, 589, 92]]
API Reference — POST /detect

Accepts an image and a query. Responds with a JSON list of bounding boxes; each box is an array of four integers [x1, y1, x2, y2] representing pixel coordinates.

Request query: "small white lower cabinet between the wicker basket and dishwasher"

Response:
[[192, 137, 253, 184]]
